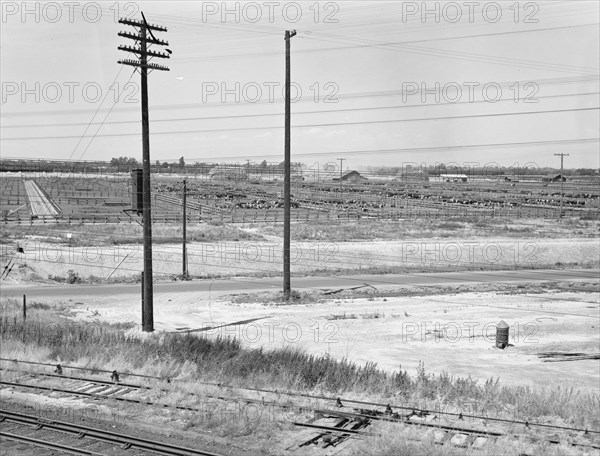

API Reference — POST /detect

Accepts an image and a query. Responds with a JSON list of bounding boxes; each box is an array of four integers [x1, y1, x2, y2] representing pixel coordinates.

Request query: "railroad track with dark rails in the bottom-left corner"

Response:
[[0, 409, 219, 456]]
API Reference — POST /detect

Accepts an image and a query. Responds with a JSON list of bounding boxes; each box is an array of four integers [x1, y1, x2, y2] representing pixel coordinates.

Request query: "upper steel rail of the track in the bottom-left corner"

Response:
[[0, 409, 221, 456]]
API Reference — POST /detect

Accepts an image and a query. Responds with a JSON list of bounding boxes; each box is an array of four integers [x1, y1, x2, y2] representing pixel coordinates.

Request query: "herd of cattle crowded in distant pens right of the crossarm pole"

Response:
[[155, 181, 599, 217]]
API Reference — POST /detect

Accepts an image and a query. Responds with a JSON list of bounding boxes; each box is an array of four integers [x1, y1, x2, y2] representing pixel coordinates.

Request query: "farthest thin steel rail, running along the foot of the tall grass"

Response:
[[0, 358, 600, 435]]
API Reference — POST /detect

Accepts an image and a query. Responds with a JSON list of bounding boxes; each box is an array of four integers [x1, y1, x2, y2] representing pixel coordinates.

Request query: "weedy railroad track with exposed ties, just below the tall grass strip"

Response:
[[0, 359, 600, 450]]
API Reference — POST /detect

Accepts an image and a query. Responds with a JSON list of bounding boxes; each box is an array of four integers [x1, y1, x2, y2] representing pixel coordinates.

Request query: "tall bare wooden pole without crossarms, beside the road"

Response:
[[283, 30, 296, 301]]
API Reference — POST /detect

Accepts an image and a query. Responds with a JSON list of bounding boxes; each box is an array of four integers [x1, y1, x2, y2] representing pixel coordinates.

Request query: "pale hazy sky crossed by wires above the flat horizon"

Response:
[[0, 0, 600, 169]]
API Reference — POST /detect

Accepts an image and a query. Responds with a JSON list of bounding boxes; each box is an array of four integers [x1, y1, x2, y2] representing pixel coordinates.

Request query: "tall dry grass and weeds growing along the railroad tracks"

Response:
[[0, 299, 600, 455]]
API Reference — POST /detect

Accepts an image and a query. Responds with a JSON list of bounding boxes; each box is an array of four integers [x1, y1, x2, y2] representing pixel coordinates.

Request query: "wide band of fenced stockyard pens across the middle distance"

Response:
[[0, 170, 600, 225]]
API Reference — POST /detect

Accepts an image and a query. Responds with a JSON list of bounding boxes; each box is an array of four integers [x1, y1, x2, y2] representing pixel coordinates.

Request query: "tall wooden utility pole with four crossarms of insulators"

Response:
[[118, 13, 171, 332]]
